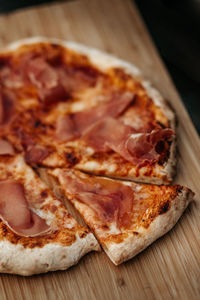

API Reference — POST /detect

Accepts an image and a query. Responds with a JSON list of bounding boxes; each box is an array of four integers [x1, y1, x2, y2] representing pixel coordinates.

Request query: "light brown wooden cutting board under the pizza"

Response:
[[0, 0, 200, 300]]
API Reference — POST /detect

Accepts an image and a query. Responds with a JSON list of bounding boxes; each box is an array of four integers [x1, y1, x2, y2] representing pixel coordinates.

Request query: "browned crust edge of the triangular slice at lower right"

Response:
[[103, 187, 194, 265]]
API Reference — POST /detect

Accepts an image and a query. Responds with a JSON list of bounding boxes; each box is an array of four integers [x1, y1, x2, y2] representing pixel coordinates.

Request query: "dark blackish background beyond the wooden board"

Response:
[[0, 0, 200, 133]]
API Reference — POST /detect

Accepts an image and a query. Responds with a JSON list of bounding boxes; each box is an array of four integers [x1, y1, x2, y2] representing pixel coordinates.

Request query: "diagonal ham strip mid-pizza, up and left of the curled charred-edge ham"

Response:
[[56, 92, 134, 142]]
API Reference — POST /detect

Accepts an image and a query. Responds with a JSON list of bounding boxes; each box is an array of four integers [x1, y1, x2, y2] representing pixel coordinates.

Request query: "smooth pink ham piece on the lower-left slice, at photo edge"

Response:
[[0, 180, 50, 237]]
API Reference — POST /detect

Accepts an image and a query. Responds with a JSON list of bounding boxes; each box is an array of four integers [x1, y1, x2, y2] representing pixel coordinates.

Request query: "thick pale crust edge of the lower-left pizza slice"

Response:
[[0, 233, 98, 276]]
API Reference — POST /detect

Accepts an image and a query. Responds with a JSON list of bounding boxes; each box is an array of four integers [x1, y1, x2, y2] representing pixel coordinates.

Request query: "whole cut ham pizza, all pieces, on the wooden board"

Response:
[[0, 38, 193, 275]]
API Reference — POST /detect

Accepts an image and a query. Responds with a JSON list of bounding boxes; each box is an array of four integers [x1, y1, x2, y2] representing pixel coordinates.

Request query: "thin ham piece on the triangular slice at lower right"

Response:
[[59, 170, 134, 229]]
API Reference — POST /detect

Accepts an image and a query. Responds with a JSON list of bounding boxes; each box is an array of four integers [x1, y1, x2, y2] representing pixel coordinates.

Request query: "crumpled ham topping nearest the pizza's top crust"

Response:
[[21, 55, 100, 104]]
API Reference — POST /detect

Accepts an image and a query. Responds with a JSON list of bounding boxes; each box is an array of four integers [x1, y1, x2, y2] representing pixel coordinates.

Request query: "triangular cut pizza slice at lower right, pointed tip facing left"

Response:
[[48, 168, 193, 265]]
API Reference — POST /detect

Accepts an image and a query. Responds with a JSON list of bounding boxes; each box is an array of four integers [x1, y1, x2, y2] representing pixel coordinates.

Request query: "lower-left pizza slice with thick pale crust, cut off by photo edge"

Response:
[[0, 139, 99, 275]]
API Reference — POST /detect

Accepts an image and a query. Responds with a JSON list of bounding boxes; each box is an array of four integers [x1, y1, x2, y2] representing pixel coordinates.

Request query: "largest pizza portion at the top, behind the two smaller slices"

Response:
[[0, 38, 176, 184]]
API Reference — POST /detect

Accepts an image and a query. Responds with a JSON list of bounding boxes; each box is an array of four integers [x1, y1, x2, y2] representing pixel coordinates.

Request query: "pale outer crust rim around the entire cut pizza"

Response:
[[0, 37, 193, 276]]
